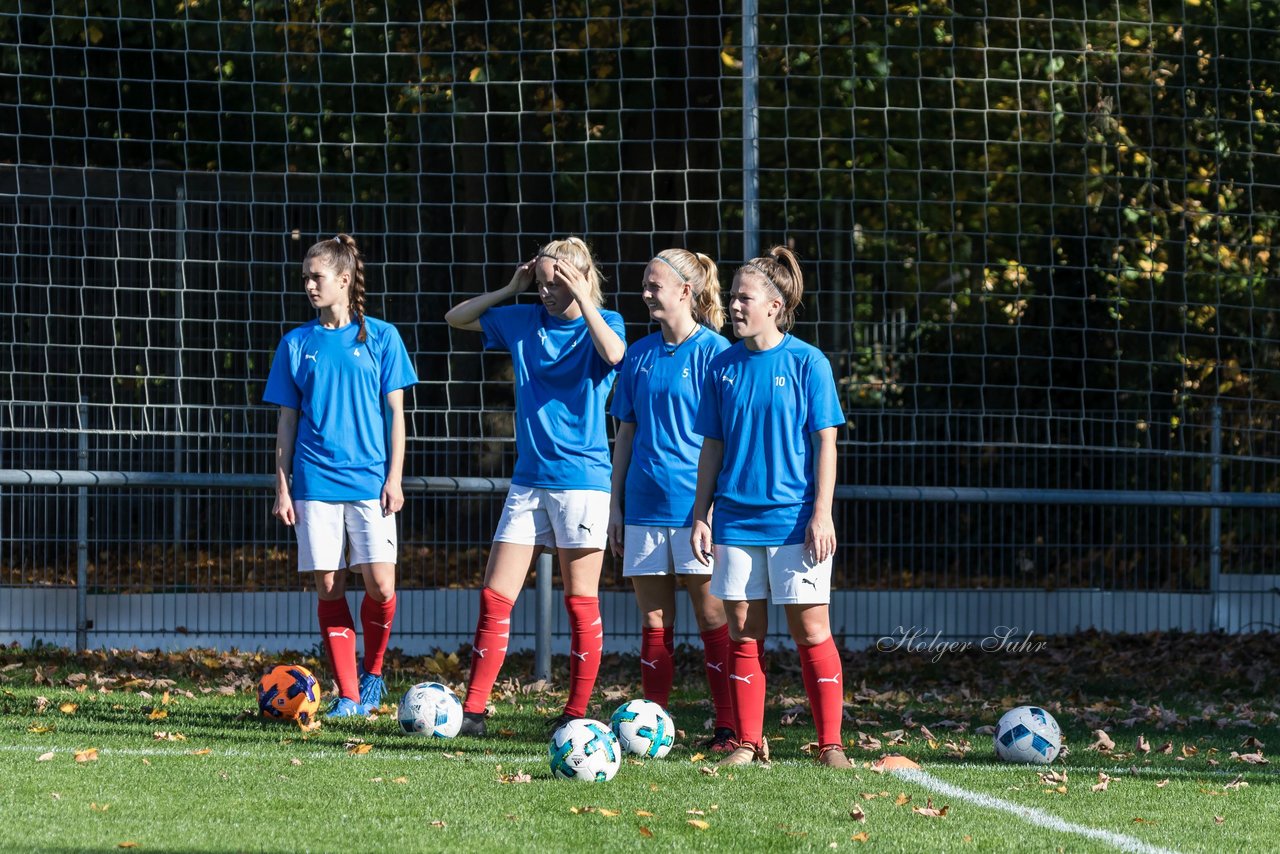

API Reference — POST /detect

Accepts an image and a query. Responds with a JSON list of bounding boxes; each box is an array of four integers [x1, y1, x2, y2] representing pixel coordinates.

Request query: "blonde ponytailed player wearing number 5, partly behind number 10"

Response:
[[609, 250, 735, 753]]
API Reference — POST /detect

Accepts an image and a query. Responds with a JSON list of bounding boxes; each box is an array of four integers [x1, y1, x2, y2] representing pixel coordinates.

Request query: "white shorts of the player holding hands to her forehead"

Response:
[[493, 484, 609, 551]]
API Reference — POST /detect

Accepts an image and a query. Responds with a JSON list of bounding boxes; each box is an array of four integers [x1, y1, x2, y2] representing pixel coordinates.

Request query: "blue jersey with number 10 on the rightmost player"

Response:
[[694, 335, 845, 545]]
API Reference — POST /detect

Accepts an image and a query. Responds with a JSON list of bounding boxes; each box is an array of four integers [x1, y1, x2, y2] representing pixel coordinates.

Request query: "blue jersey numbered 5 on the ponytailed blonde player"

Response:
[[613, 324, 728, 528]]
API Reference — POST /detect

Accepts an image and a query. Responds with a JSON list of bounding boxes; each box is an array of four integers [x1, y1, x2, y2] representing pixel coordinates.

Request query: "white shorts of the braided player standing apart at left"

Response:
[[293, 498, 399, 572]]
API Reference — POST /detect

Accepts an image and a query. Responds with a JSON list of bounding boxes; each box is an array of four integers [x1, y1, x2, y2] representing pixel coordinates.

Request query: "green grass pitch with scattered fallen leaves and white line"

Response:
[[0, 640, 1280, 851]]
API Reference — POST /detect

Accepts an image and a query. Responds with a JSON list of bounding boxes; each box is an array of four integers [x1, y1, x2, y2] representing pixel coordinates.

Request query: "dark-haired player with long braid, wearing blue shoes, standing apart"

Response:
[[262, 234, 417, 717]]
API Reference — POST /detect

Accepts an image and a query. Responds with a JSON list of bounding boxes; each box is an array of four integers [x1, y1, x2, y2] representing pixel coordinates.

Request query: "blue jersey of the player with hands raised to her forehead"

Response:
[[480, 303, 626, 492]]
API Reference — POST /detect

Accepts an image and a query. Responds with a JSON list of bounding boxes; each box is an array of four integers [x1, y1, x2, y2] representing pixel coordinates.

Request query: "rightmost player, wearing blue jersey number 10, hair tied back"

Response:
[[691, 246, 850, 768]]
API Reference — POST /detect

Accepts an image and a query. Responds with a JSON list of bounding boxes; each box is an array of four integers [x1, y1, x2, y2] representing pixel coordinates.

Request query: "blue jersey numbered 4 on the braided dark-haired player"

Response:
[[262, 318, 417, 501]]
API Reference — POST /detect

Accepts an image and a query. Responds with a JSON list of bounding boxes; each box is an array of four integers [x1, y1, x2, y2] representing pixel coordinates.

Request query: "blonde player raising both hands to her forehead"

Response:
[[444, 237, 627, 735]]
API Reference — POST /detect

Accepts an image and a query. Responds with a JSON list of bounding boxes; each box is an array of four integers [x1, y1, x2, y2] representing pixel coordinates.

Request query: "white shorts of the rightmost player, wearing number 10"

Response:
[[710, 543, 831, 604]]
